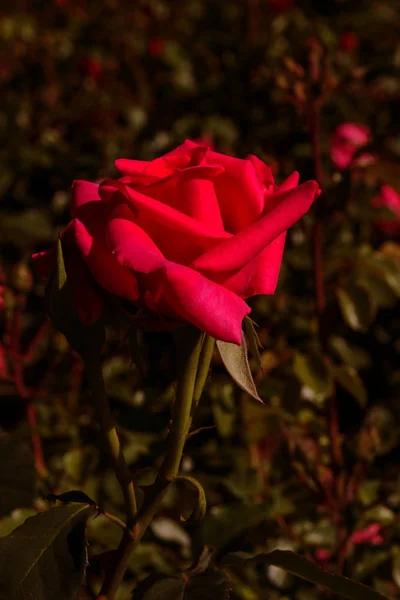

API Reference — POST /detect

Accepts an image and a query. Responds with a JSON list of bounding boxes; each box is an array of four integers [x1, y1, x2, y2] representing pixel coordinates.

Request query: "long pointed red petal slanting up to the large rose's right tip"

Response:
[[192, 181, 318, 277]]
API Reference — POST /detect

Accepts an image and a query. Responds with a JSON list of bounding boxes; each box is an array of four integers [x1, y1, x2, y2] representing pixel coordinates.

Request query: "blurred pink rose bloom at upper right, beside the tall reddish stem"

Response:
[[330, 122, 371, 169]]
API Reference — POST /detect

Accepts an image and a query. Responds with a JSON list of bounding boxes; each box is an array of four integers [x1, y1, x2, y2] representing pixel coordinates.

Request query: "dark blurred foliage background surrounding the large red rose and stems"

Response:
[[0, 0, 400, 600]]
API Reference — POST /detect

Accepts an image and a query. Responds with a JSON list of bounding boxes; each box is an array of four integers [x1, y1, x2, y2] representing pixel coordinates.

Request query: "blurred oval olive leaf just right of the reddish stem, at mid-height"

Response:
[[336, 286, 377, 331]]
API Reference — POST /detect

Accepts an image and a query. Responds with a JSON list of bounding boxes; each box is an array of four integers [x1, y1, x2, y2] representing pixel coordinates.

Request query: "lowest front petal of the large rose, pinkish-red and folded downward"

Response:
[[152, 263, 251, 344]]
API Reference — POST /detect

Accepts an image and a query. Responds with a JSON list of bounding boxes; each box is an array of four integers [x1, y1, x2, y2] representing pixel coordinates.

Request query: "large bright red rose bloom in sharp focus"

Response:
[[35, 140, 319, 344]]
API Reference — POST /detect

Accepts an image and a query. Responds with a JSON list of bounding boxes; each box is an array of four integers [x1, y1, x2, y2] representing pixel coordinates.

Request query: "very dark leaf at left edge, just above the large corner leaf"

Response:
[[0, 432, 36, 517]]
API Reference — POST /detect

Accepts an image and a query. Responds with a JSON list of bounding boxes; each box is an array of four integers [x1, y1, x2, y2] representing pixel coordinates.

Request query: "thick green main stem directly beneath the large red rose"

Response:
[[98, 327, 208, 600]]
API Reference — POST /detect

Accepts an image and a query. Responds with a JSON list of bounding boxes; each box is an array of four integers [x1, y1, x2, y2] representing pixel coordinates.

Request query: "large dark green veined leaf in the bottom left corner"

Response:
[[0, 504, 94, 600]]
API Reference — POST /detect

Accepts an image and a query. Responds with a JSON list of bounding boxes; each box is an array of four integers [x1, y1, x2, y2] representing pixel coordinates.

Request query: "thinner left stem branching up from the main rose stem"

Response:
[[84, 354, 137, 529]]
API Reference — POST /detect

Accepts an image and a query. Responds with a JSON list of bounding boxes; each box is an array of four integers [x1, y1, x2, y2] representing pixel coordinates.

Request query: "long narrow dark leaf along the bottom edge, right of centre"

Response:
[[230, 550, 388, 600]]
